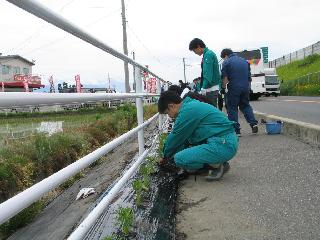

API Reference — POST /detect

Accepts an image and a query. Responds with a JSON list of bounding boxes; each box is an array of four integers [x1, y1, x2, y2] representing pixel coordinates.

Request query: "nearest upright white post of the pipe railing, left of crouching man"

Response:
[[134, 67, 144, 156]]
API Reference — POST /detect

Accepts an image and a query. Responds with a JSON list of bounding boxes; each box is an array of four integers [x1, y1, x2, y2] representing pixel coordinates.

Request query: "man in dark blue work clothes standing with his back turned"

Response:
[[221, 48, 258, 136]]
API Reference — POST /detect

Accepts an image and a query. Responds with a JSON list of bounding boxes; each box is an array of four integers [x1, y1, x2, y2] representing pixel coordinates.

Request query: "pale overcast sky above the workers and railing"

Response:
[[0, 0, 320, 90]]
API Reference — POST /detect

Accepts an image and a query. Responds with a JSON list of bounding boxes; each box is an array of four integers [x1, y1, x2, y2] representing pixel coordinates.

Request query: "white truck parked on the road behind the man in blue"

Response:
[[235, 49, 280, 100]]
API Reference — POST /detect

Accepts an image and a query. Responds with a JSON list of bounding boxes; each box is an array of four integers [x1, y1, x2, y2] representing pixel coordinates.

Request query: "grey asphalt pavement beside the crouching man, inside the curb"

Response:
[[177, 118, 320, 240]]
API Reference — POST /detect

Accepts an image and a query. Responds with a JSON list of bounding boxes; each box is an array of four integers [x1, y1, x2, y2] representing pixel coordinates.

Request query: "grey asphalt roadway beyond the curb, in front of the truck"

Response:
[[250, 96, 320, 125]]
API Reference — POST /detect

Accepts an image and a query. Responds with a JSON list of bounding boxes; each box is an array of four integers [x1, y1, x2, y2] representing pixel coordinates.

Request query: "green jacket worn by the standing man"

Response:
[[201, 47, 221, 89]]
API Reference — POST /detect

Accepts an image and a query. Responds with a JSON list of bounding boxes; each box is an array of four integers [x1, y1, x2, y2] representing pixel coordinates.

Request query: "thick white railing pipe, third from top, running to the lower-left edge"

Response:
[[0, 114, 159, 225]]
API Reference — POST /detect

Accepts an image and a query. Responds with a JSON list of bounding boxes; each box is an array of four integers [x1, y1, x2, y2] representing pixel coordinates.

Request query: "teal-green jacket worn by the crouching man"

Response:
[[163, 97, 234, 158]]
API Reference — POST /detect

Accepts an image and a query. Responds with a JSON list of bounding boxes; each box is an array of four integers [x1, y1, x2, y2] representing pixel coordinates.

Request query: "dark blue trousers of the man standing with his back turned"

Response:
[[226, 89, 258, 133]]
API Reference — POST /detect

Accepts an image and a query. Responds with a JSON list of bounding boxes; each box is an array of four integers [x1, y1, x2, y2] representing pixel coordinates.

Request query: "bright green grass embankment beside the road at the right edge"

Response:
[[277, 54, 320, 96]]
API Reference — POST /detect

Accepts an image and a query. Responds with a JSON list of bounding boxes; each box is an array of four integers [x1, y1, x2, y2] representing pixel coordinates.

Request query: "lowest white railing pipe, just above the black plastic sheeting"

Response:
[[68, 137, 157, 240]]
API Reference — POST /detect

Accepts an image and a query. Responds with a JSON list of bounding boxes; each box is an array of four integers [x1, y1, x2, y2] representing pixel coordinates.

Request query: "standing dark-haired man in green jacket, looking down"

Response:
[[189, 38, 221, 107]]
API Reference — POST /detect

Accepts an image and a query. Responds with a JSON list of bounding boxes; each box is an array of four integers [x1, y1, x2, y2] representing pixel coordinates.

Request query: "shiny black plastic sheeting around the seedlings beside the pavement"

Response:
[[84, 134, 178, 240]]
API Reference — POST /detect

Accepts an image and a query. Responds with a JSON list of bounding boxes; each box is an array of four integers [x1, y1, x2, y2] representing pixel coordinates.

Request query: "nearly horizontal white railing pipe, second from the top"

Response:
[[0, 92, 156, 108]]
